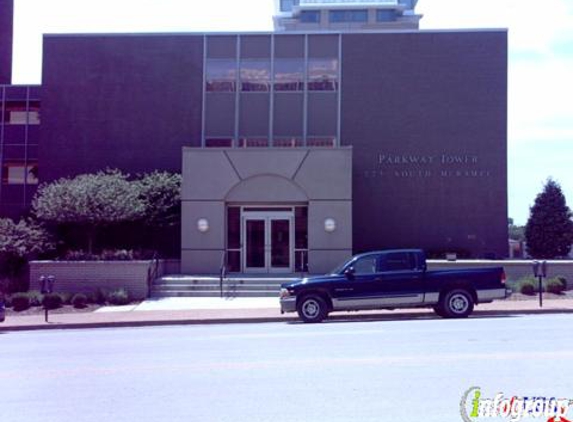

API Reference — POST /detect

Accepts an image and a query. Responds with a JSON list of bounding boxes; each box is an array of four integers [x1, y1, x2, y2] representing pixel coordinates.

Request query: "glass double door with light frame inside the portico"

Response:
[[243, 211, 294, 273]]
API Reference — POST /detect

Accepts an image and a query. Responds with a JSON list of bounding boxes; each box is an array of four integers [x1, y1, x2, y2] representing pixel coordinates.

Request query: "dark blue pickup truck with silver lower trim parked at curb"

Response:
[[280, 249, 511, 322]]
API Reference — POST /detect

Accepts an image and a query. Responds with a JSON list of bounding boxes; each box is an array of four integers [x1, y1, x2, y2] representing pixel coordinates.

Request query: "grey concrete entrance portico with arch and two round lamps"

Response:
[[181, 148, 352, 274]]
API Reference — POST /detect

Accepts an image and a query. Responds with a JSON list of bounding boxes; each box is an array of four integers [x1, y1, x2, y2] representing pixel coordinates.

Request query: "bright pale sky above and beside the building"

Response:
[[8, 0, 573, 224]]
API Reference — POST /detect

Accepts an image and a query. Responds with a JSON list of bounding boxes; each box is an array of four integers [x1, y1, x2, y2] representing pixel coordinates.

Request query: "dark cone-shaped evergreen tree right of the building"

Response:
[[525, 179, 573, 259]]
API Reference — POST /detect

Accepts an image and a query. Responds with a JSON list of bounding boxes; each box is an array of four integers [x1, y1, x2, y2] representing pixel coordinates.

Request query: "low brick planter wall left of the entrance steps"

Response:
[[30, 261, 152, 299]]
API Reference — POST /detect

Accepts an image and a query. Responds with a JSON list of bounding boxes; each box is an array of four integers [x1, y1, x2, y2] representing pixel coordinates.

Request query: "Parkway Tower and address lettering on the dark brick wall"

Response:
[[364, 153, 491, 178]]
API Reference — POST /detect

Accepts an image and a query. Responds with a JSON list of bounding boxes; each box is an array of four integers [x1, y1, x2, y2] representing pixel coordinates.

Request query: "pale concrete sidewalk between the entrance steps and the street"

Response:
[[0, 298, 573, 332]]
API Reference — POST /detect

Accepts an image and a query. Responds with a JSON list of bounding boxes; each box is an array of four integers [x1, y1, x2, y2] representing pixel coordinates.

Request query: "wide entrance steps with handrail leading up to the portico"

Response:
[[150, 274, 300, 298]]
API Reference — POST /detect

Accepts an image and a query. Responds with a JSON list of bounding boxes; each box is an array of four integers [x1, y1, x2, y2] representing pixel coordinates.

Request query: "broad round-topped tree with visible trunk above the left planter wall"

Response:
[[32, 169, 145, 253]]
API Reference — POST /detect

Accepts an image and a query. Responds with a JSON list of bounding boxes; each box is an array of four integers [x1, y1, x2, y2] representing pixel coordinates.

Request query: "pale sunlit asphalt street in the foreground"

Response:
[[0, 315, 573, 422]]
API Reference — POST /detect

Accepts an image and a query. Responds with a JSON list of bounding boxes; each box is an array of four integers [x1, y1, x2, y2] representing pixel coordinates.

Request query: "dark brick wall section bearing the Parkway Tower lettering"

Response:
[[341, 31, 508, 257]]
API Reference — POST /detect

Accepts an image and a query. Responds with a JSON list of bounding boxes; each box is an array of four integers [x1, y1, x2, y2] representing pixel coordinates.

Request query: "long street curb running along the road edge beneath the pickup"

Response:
[[0, 308, 573, 334]]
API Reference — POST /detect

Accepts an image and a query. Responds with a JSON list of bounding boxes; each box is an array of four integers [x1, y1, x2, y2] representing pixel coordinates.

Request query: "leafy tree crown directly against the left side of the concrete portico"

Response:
[[135, 171, 181, 227]]
